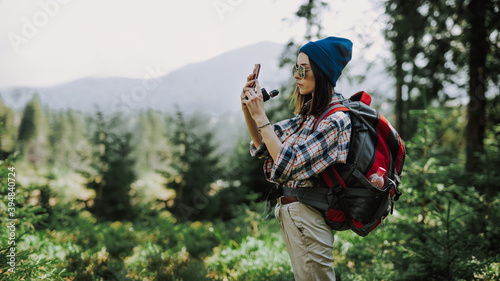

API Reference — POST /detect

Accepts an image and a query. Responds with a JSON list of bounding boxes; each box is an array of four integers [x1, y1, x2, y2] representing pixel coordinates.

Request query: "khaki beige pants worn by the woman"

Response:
[[274, 202, 335, 281]]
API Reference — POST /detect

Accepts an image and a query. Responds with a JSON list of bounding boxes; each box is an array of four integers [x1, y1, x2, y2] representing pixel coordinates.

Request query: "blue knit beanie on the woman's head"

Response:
[[299, 36, 352, 87]]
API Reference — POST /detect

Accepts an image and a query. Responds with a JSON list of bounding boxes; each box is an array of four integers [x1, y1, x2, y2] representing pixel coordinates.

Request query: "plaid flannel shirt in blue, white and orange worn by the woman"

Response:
[[250, 93, 351, 188]]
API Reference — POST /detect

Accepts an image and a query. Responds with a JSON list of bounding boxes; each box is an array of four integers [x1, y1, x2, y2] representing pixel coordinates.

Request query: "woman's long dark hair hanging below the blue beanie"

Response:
[[292, 59, 334, 117]]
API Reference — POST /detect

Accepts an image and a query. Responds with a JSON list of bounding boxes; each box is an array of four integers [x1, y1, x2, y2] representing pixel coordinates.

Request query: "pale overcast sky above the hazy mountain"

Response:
[[0, 0, 381, 87]]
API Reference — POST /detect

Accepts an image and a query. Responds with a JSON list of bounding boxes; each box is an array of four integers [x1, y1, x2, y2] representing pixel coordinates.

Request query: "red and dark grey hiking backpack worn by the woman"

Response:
[[283, 92, 406, 236]]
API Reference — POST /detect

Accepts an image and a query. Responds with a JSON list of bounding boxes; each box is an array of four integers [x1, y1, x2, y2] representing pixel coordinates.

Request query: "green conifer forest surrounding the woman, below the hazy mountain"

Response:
[[0, 0, 500, 281]]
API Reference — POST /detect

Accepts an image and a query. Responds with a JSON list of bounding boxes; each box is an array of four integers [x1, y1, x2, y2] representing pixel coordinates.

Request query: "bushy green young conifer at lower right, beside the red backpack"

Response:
[[386, 105, 500, 280]]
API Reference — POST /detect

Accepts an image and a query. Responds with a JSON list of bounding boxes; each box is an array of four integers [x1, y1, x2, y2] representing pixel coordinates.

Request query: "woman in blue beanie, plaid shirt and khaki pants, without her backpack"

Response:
[[241, 37, 352, 281]]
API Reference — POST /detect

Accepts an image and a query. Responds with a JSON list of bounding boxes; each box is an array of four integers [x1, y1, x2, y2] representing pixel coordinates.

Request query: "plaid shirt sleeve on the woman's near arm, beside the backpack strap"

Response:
[[265, 112, 351, 182]]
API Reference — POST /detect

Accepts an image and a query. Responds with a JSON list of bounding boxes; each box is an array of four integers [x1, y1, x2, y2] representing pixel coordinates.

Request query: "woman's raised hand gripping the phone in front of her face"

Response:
[[241, 80, 268, 124]]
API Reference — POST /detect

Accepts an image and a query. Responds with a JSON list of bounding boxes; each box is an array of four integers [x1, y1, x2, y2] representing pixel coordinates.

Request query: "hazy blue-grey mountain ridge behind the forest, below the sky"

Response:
[[0, 42, 289, 115]]
